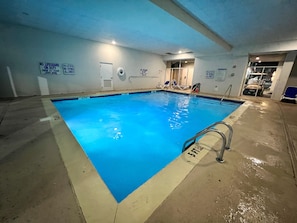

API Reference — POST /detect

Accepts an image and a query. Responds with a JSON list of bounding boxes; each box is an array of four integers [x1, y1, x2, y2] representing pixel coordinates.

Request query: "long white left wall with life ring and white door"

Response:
[[0, 23, 166, 97]]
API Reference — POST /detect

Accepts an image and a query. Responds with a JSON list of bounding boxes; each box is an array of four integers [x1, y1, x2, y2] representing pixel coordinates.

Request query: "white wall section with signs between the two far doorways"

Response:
[[193, 55, 248, 96]]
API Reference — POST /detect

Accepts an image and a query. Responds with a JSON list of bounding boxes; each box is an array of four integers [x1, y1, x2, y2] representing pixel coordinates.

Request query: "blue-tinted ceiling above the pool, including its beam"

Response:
[[0, 0, 297, 55]]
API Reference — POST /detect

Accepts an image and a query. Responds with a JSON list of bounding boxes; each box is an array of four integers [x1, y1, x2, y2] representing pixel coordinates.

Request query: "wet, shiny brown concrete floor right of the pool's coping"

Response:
[[146, 98, 297, 223]]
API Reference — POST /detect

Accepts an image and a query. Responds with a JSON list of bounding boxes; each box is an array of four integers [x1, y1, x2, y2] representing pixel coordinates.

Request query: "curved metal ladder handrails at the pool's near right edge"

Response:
[[182, 121, 233, 163]]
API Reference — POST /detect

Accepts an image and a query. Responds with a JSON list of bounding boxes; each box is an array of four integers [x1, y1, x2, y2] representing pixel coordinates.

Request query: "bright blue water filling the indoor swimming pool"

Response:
[[53, 91, 240, 202]]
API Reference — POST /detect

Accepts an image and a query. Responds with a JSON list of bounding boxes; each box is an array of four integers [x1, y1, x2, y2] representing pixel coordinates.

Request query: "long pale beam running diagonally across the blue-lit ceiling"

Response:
[[150, 0, 232, 51]]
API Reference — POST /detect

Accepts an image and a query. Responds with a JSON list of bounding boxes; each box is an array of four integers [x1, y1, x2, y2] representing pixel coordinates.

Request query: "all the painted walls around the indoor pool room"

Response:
[[0, 23, 296, 100]]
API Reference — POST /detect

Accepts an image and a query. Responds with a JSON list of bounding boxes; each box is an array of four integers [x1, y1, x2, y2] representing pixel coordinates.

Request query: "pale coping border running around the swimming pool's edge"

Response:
[[42, 91, 250, 223]]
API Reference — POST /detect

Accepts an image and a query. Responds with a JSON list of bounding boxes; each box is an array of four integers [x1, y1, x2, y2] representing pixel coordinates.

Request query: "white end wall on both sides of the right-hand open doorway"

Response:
[[193, 52, 297, 101]]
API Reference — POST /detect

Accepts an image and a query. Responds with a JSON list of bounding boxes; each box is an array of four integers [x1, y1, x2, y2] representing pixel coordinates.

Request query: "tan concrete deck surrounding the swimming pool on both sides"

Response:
[[0, 89, 297, 223]]
